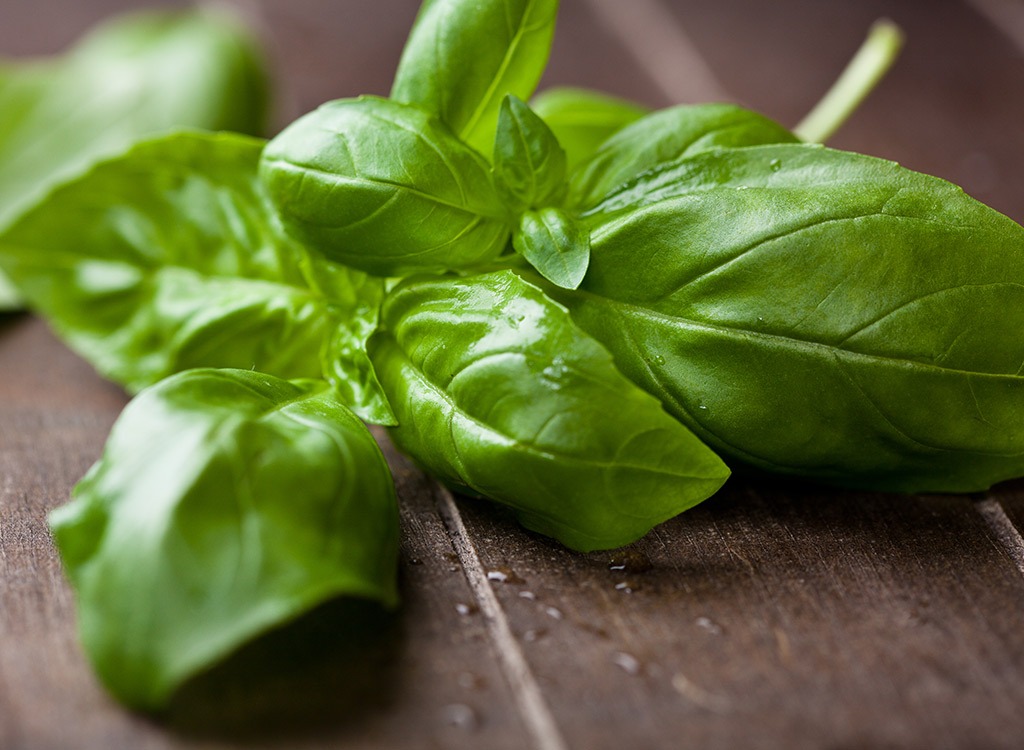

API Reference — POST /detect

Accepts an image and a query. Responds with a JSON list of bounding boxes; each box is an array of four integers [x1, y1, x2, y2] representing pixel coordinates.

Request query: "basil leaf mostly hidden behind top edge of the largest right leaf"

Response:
[[569, 105, 798, 207]]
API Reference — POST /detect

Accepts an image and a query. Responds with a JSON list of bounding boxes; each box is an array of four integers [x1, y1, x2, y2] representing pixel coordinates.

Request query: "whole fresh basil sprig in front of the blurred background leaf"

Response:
[[0, 0, 1024, 709]]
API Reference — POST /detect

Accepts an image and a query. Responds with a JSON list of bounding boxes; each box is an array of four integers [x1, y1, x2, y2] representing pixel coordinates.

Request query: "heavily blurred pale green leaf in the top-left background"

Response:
[[0, 9, 266, 307]]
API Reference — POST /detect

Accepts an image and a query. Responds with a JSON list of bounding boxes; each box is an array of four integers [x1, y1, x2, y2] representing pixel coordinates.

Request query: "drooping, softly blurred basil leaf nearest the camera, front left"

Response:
[[50, 370, 398, 710]]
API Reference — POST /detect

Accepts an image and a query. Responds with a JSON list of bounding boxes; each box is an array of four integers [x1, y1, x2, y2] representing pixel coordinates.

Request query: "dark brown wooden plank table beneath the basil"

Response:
[[0, 0, 1024, 750]]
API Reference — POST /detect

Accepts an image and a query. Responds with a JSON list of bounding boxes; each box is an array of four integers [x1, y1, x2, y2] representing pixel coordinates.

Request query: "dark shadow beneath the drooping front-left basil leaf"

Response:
[[159, 598, 403, 746]]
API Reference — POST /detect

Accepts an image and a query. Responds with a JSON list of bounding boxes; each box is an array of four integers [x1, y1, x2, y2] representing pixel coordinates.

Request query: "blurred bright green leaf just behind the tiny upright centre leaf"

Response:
[[530, 88, 648, 170]]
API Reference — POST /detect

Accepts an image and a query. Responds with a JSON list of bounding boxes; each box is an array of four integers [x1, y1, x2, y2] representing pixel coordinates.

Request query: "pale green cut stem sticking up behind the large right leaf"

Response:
[[794, 18, 903, 143]]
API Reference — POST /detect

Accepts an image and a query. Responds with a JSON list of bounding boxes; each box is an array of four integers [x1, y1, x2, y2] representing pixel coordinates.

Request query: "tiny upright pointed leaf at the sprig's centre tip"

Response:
[[494, 95, 566, 211]]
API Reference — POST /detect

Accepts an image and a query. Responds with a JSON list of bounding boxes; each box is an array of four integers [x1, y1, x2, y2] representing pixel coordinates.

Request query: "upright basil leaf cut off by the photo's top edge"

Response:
[[391, 0, 558, 154]]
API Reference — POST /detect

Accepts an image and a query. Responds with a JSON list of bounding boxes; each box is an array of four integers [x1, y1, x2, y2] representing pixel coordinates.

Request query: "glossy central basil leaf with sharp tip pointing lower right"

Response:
[[370, 270, 728, 550]]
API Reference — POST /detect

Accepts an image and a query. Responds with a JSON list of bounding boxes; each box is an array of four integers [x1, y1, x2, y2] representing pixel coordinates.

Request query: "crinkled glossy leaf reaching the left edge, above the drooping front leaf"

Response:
[[0, 133, 383, 418]]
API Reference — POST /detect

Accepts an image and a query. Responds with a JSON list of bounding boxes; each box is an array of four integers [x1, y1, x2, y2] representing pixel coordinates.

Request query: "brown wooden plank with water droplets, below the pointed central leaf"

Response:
[[461, 482, 1024, 748]]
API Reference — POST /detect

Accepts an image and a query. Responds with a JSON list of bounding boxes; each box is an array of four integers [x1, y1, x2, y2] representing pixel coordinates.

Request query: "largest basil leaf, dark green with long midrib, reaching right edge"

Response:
[[555, 145, 1024, 491]]
